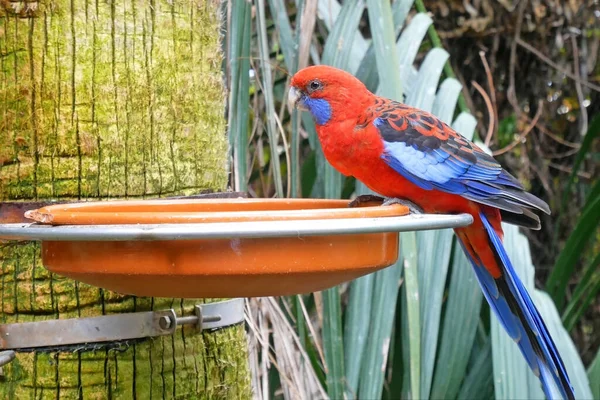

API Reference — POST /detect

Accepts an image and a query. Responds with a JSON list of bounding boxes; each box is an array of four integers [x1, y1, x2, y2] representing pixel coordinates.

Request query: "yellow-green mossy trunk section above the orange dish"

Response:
[[0, 0, 227, 199]]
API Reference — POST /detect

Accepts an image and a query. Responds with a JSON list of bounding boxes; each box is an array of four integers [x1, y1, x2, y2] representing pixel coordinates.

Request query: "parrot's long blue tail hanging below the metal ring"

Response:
[[459, 213, 575, 399]]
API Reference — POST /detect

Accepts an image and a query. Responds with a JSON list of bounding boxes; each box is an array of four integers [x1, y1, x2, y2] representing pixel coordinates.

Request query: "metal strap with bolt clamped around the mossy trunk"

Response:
[[0, 299, 244, 354]]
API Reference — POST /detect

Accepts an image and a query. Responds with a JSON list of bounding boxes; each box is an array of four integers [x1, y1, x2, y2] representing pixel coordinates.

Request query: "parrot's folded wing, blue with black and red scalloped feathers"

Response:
[[373, 106, 550, 217]]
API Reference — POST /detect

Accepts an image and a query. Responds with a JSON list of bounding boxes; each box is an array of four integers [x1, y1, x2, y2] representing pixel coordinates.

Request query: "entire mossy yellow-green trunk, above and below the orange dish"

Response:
[[0, 0, 250, 399]]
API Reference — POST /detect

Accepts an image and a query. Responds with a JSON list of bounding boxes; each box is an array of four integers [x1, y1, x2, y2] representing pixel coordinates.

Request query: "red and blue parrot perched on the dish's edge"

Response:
[[287, 65, 575, 399]]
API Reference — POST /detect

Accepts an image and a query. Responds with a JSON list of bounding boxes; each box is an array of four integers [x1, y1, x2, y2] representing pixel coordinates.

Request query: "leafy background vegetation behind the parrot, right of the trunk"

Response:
[[224, 0, 600, 399]]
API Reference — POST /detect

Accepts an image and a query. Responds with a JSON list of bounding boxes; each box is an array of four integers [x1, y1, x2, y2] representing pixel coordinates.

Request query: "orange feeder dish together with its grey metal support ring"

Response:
[[0, 199, 471, 298]]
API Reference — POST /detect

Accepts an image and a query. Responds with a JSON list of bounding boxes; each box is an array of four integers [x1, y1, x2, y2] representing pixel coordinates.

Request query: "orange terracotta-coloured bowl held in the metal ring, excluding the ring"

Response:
[[26, 199, 408, 298]]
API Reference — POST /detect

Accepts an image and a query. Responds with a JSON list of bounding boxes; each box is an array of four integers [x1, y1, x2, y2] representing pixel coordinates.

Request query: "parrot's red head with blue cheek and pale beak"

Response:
[[288, 65, 372, 125]]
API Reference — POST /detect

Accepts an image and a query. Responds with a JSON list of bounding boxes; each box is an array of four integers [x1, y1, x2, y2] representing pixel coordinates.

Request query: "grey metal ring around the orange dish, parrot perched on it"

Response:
[[0, 214, 473, 241]]
